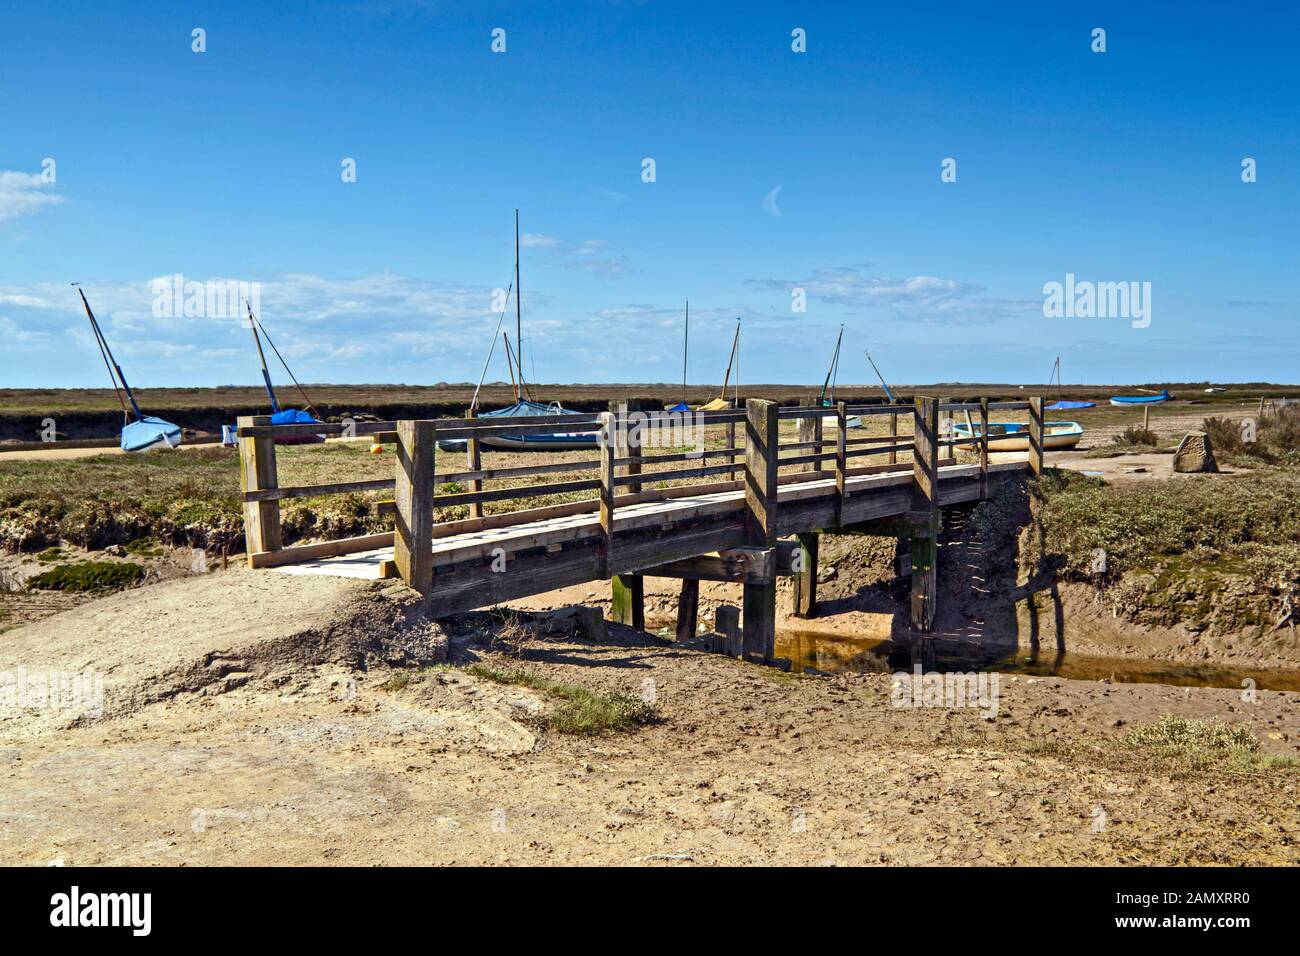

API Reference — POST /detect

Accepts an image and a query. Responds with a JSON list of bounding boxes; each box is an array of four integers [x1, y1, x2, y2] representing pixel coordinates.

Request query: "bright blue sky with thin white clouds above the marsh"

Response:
[[0, 0, 1300, 388]]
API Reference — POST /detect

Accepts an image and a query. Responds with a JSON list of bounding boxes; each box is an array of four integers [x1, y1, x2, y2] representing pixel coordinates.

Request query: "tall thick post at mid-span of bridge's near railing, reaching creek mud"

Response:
[[742, 398, 779, 663]]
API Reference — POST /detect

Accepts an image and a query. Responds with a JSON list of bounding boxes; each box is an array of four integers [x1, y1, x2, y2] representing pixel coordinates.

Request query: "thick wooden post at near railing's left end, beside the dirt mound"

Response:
[[393, 420, 438, 594]]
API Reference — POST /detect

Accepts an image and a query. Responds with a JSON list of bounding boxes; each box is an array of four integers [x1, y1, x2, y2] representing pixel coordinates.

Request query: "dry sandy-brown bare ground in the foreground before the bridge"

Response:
[[0, 570, 1300, 865]]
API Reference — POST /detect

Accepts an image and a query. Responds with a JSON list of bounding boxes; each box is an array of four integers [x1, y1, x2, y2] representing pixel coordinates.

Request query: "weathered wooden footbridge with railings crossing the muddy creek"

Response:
[[238, 398, 1044, 662]]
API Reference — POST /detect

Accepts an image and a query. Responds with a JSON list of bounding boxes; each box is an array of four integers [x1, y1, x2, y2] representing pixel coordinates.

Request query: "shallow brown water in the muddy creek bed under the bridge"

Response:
[[776, 631, 1300, 691]]
